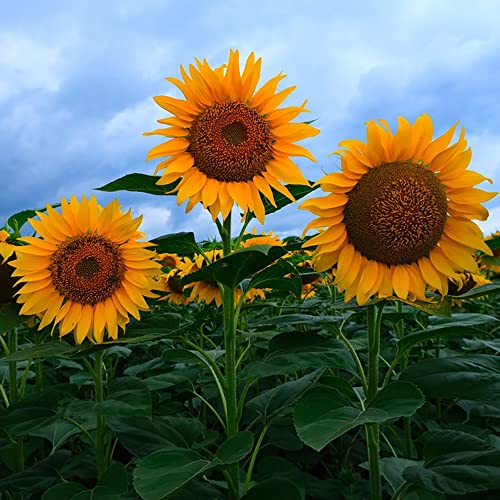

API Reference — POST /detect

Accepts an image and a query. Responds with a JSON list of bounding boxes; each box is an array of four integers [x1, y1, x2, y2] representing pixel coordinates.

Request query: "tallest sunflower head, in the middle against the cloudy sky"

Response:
[[145, 50, 319, 223]]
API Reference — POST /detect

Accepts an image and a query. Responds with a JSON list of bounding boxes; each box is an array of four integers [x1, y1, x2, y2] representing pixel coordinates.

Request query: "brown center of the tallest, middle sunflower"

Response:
[[188, 100, 273, 182]]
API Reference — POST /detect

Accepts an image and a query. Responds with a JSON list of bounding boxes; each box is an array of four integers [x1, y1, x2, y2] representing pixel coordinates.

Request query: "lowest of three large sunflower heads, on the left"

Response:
[[12, 196, 160, 344]]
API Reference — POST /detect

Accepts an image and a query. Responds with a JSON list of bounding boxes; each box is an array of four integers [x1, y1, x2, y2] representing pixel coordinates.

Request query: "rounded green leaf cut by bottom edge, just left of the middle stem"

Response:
[[134, 448, 211, 500]]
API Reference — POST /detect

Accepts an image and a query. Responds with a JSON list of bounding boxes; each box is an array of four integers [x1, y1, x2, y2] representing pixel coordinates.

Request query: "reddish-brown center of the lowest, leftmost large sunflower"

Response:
[[50, 234, 125, 305]]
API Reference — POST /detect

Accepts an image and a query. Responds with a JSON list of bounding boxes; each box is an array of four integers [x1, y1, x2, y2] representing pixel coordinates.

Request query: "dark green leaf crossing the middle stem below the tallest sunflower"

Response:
[[182, 245, 286, 288]]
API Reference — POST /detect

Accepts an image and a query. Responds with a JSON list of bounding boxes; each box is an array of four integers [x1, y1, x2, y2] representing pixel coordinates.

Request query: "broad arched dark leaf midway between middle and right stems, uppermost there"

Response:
[[241, 332, 357, 378]]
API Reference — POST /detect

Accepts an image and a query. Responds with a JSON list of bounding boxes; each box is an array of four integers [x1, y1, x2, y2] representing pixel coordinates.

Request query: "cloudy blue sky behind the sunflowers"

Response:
[[0, 0, 500, 240]]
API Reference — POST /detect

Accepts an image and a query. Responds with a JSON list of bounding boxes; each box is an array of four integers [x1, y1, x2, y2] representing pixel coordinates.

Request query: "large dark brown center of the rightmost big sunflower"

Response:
[[344, 162, 448, 265]]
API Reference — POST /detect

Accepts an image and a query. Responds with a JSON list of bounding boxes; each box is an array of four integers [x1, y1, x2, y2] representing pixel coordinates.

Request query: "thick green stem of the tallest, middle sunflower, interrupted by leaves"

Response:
[[219, 214, 240, 498]]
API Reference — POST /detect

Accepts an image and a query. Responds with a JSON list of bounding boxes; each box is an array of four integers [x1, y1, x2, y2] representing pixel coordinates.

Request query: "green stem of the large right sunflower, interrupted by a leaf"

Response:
[[365, 305, 382, 500]]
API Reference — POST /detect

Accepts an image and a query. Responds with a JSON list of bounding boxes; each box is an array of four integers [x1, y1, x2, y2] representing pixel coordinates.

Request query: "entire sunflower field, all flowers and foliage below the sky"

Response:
[[0, 51, 500, 500]]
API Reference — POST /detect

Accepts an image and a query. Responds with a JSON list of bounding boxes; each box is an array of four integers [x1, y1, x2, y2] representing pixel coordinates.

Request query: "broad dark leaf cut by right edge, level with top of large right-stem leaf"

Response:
[[400, 354, 500, 401]]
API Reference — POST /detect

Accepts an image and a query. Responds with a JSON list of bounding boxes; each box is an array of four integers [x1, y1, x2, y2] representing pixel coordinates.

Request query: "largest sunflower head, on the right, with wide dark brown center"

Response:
[[301, 114, 496, 304]]
